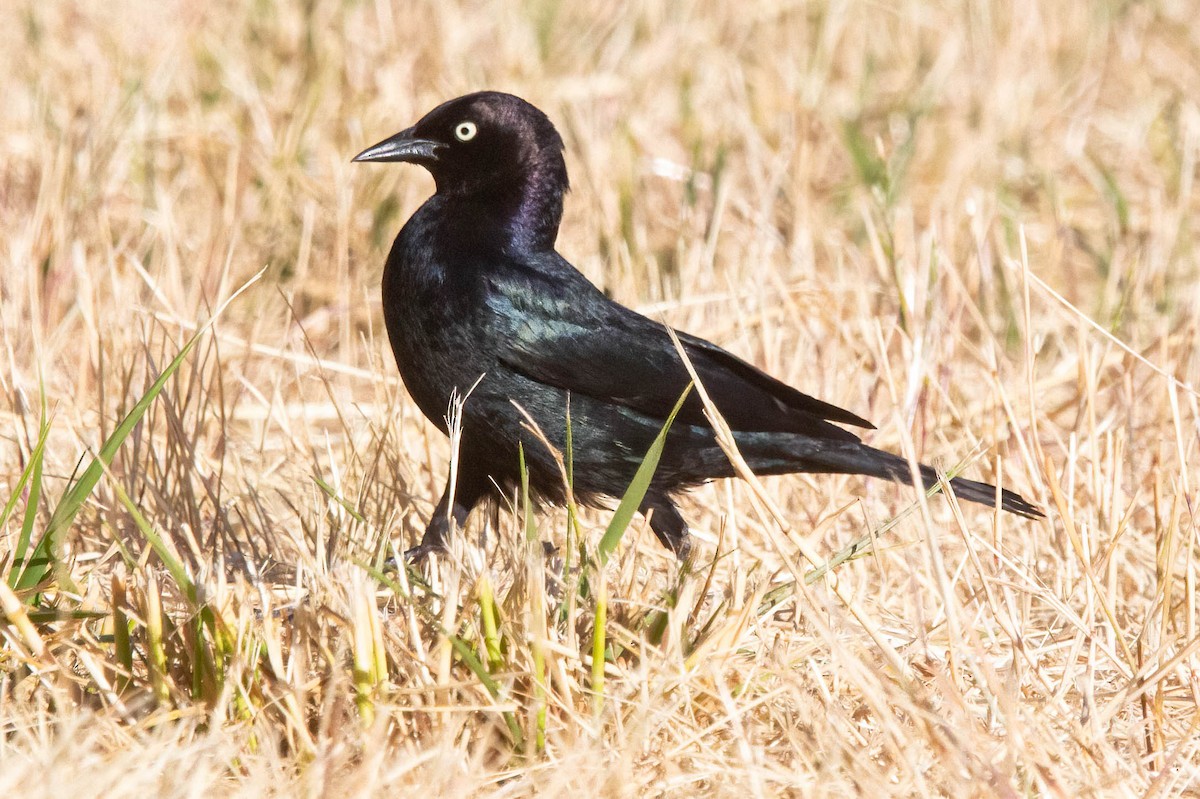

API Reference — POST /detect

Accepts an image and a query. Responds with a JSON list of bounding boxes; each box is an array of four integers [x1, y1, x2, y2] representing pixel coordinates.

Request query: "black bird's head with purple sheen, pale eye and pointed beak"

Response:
[[354, 91, 568, 247]]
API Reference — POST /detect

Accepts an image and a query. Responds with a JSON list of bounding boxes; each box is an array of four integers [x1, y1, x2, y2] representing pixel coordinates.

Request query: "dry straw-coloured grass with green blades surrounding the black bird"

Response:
[[0, 0, 1200, 797]]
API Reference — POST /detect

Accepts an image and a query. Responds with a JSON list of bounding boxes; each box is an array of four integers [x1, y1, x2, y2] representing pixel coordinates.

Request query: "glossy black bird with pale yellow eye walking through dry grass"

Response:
[[355, 92, 1040, 557]]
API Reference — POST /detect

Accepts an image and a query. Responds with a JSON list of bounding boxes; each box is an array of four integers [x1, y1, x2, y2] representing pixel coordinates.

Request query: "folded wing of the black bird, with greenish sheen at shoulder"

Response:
[[487, 259, 874, 440]]
